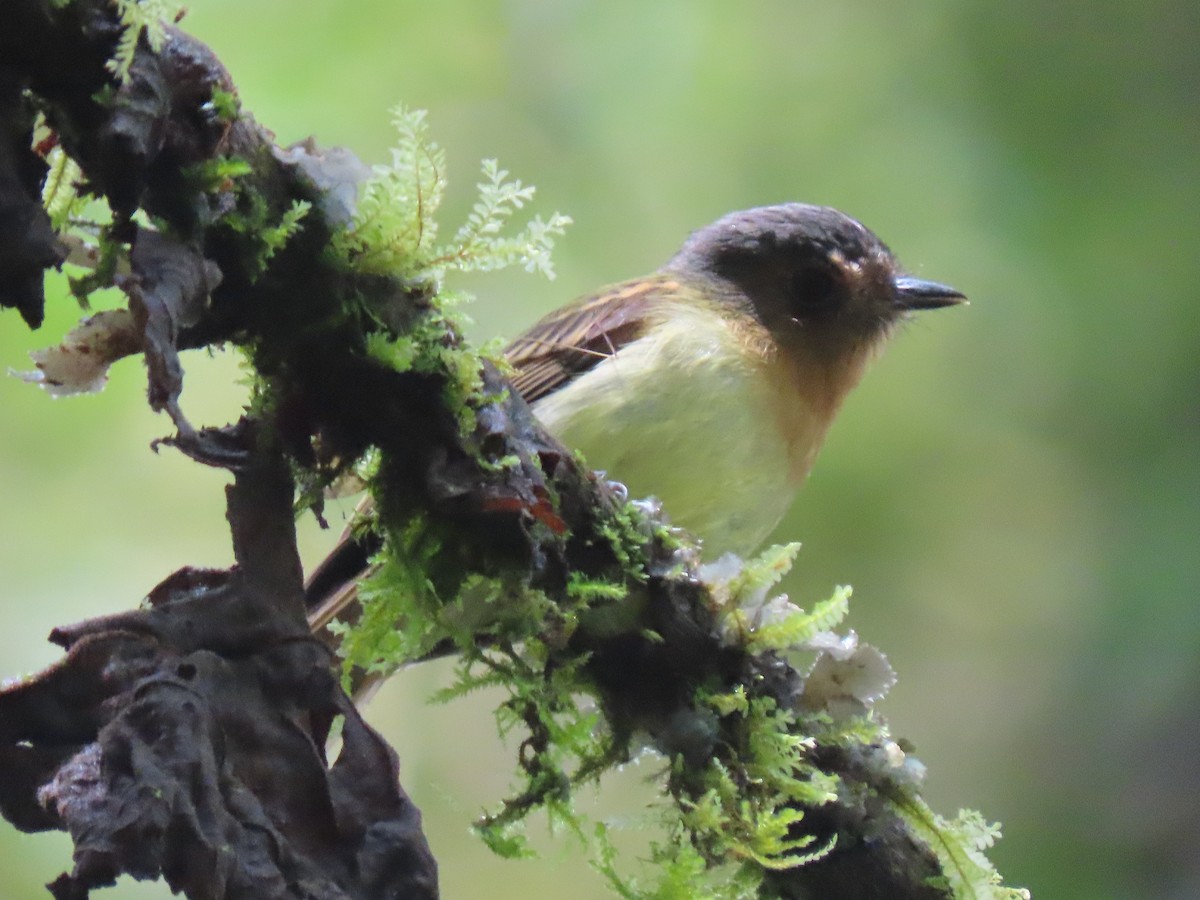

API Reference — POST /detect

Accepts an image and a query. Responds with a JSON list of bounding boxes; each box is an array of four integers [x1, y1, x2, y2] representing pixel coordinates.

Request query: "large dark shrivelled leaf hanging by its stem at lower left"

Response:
[[0, 467, 437, 900]]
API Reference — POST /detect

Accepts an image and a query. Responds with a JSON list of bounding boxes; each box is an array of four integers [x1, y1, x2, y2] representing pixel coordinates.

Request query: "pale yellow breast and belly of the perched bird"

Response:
[[534, 305, 836, 557]]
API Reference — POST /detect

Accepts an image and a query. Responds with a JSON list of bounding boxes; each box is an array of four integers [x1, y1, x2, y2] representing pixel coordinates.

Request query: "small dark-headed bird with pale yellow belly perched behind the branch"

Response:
[[310, 203, 965, 648]]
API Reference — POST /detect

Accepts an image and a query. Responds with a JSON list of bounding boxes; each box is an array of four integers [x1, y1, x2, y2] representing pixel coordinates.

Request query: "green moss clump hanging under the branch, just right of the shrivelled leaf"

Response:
[[335, 501, 625, 857]]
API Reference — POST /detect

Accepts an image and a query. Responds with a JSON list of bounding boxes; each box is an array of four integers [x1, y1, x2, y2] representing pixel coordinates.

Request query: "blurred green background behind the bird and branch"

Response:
[[0, 0, 1200, 900]]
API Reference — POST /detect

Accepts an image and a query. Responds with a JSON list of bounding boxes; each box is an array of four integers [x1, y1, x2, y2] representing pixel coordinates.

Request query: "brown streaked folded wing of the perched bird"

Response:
[[504, 275, 680, 403]]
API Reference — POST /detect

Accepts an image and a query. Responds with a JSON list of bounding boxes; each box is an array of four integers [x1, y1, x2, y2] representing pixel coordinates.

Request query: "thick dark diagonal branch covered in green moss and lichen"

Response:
[[0, 0, 1012, 898]]
